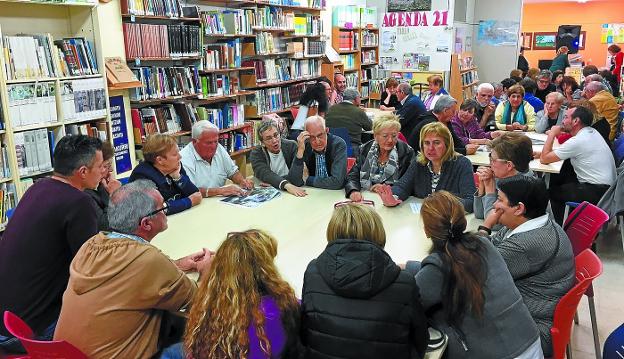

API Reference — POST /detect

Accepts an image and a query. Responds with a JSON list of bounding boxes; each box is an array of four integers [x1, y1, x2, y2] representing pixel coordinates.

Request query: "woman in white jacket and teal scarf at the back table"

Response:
[[494, 85, 535, 131]]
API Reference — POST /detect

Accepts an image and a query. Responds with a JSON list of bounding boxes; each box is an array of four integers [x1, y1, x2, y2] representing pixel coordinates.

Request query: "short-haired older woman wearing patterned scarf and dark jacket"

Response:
[[345, 113, 414, 202]]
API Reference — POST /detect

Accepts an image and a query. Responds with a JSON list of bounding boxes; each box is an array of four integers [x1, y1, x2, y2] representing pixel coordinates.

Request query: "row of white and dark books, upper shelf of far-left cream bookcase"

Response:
[[2, 33, 98, 80]]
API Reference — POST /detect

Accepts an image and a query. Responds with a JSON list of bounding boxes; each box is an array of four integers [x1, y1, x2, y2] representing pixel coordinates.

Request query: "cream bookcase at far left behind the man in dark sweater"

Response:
[[0, 1, 111, 229]]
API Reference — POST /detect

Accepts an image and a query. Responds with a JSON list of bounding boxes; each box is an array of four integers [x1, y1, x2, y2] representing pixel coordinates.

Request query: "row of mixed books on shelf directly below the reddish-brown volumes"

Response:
[[130, 66, 201, 101]]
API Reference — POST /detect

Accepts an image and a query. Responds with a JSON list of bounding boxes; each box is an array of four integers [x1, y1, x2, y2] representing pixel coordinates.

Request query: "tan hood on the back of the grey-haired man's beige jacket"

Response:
[[69, 232, 152, 295]]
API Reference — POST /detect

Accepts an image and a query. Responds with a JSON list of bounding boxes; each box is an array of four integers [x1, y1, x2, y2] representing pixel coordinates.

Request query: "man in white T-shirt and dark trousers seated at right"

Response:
[[540, 107, 615, 224]]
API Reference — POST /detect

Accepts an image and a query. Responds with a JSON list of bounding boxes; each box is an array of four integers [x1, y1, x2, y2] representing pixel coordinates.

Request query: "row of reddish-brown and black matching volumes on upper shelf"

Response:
[[123, 23, 201, 59]]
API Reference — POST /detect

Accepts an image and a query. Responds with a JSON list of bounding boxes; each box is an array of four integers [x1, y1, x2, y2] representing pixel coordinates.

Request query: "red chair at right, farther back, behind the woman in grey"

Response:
[[563, 202, 609, 359]]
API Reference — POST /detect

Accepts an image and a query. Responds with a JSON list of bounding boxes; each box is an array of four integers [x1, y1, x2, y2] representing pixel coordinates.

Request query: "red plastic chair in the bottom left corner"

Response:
[[4, 311, 87, 359]]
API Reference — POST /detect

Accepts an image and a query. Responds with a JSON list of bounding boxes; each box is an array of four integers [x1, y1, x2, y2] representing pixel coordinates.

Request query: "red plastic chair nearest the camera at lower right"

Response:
[[550, 249, 602, 359]]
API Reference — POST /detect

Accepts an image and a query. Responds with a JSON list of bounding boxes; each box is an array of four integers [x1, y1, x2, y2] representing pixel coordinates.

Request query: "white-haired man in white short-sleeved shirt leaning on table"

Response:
[[180, 120, 253, 197]]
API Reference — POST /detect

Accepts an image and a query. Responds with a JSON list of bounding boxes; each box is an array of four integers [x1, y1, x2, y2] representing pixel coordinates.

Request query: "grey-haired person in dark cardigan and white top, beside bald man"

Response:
[[249, 120, 307, 197]]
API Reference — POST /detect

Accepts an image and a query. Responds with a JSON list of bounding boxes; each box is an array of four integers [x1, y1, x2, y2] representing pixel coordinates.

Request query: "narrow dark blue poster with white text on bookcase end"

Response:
[[108, 96, 132, 174]]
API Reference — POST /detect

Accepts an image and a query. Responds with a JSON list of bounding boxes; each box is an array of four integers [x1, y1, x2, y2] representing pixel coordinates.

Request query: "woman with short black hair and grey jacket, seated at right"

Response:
[[479, 176, 576, 357]]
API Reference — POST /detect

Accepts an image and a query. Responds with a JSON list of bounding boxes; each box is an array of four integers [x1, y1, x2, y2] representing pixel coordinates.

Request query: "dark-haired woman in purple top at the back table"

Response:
[[451, 99, 502, 145]]
